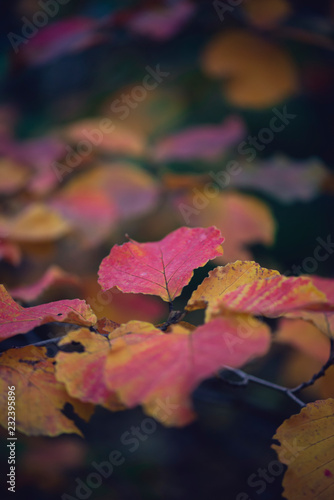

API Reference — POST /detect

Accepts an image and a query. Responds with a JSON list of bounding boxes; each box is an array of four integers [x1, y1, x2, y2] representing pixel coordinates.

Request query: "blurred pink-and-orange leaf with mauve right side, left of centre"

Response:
[[49, 162, 159, 243]]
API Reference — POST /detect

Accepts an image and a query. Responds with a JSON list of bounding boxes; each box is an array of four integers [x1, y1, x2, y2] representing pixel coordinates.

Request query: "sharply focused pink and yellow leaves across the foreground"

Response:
[[0, 227, 334, 499]]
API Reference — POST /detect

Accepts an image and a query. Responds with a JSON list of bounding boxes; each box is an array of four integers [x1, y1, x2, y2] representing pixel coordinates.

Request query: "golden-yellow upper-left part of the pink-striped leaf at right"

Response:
[[186, 260, 279, 311]]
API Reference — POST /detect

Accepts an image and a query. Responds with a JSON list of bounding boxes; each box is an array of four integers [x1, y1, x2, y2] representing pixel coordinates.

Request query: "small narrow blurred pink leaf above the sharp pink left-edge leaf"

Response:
[[9, 266, 79, 302]]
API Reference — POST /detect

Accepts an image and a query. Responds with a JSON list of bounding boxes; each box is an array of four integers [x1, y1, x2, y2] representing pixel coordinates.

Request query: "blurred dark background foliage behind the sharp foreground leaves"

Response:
[[0, 0, 334, 500]]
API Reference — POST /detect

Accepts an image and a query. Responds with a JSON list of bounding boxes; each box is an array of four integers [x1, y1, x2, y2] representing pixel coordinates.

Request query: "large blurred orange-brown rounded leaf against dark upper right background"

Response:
[[202, 30, 299, 109]]
